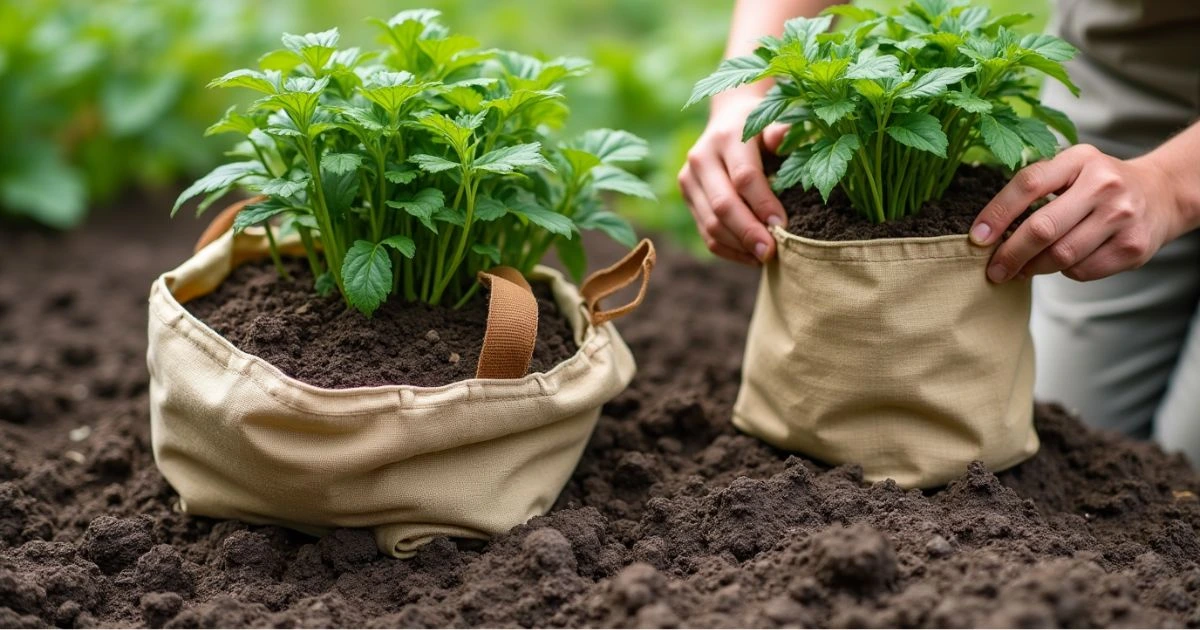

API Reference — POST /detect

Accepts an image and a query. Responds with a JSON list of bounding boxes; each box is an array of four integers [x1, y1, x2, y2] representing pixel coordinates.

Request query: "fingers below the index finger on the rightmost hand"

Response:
[[988, 188, 1111, 282]]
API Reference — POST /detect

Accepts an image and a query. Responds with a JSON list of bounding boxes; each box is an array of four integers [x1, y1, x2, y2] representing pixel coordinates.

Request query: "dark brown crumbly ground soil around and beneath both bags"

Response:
[[0, 194, 1200, 628]]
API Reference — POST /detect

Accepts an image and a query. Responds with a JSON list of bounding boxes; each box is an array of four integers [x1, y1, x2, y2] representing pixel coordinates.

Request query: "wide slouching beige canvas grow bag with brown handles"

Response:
[[148, 210, 654, 557]]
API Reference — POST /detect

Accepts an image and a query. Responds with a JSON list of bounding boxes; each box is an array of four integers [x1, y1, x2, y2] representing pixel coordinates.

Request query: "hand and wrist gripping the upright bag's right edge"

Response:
[[971, 122, 1200, 282]]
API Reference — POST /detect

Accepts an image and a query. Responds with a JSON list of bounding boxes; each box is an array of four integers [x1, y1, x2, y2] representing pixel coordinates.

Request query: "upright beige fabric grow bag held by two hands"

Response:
[[733, 228, 1038, 487]]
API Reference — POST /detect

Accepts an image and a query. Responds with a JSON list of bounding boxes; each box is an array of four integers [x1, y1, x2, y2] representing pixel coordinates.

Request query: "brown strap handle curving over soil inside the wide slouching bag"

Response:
[[475, 266, 538, 378]]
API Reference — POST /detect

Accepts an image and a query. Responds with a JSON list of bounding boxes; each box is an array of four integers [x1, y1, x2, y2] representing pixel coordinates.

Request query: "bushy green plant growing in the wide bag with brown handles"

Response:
[[174, 10, 654, 316]]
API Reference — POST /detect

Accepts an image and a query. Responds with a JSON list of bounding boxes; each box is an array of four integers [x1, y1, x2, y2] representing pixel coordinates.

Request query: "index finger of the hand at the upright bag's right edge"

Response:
[[971, 144, 1103, 247]]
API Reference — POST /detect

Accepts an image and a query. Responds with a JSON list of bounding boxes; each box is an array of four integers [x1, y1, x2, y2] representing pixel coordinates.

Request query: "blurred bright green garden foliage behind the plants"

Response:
[[0, 0, 1048, 248]]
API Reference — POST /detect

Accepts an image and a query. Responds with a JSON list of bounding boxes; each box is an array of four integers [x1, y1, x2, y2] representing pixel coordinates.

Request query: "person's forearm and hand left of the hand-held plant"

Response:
[[679, 0, 845, 264]]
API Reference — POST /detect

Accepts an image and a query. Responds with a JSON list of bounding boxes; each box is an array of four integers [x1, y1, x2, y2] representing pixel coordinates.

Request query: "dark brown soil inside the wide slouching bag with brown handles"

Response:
[[185, 260, 578, 388]]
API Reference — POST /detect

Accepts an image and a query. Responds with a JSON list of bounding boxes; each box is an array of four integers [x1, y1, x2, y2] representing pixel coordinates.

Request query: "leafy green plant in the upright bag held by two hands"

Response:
[[688, 0, 1078, 222]]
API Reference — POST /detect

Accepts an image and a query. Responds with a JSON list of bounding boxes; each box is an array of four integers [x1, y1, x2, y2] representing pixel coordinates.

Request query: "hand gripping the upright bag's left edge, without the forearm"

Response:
[[679, 91, 787, 265]]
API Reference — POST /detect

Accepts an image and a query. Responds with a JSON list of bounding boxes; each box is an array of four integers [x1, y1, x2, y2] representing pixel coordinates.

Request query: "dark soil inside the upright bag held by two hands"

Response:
[[779, 166, 1020, 241]]
